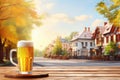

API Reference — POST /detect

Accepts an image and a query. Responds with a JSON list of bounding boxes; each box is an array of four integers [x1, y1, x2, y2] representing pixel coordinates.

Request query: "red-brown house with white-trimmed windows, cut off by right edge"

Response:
[[103, 23, 120, 54]]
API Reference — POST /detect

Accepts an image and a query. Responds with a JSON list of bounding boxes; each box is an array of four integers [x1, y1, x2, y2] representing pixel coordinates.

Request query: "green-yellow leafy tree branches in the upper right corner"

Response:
[[96, 0, 120, 27]]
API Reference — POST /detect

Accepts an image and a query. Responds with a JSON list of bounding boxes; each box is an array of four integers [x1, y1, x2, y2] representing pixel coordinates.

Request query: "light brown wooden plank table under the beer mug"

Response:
[[0, 66, 120, 80]]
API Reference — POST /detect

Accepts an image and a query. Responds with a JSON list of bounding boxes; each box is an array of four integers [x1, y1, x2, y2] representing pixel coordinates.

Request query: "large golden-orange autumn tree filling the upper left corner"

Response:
[[0, 0, 40, 62]]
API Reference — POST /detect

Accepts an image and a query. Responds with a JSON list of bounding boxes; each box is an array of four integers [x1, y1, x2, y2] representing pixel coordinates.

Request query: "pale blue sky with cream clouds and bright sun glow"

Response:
[[31, 0, 107, 50]]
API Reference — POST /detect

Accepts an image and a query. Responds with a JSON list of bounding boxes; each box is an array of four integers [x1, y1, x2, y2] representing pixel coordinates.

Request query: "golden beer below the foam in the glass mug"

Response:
[[17, 46, 33, 74]]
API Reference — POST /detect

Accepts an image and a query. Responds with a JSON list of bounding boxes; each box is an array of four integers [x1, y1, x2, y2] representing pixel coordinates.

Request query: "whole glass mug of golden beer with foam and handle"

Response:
[[10, 40, 34, 74]]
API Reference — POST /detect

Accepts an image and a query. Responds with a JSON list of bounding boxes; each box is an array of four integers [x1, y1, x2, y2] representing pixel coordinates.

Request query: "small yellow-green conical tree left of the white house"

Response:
[[53, 37, 62, 55]]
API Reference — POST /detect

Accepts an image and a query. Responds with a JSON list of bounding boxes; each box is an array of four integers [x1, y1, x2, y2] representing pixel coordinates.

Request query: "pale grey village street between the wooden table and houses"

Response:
[[34, 57, 120, 67]]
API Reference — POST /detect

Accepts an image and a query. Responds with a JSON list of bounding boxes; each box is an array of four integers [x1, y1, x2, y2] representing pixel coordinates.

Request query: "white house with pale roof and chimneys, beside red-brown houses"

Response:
[[71, 27, 95, 58]]
